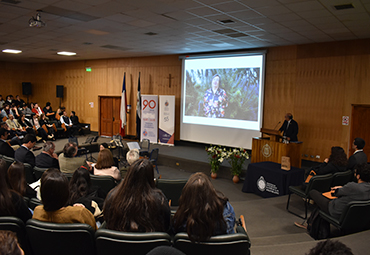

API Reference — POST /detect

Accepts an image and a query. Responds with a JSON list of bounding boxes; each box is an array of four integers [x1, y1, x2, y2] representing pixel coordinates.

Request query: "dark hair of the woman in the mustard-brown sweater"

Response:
[[40, 168, 69, 212]]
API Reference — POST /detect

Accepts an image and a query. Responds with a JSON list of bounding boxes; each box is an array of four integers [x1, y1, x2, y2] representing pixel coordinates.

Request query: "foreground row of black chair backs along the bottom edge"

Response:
[[0, 217, 251, 255]]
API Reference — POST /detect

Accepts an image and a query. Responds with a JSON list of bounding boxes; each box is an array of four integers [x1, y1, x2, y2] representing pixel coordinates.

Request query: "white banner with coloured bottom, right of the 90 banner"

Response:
[[158, 96, 175, 146]]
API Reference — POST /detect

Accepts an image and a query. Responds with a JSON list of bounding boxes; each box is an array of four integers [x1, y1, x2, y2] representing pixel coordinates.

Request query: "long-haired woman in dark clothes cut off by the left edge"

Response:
[[0, 159, 32, 223]]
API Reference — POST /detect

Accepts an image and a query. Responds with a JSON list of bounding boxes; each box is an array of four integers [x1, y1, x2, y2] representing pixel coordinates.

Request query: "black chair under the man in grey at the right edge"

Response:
[[319, 200, 370, 234]]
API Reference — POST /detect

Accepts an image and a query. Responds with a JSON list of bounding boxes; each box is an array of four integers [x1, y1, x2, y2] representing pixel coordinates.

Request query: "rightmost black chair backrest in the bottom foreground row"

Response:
[[174, 233, 251, 255]]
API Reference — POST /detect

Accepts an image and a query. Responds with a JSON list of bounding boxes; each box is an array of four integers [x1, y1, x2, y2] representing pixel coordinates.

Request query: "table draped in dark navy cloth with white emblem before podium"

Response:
[[242, 161, 304, 198]]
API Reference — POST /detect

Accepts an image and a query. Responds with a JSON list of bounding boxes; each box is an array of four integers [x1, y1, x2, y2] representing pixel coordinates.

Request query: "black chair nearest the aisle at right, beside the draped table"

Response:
[[286, 174, 332, 219]]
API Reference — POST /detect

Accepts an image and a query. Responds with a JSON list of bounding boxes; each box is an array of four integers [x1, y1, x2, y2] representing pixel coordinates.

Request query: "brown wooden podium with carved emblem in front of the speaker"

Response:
[[251, 128, 302, 168]]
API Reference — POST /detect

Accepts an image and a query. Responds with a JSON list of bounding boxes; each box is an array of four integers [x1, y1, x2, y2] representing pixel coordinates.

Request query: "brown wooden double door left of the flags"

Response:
[[99, 96, 121, 137]]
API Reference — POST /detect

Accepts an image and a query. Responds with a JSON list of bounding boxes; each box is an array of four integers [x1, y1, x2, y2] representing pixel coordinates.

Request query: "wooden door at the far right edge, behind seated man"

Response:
[[349, 105, 370, 159]]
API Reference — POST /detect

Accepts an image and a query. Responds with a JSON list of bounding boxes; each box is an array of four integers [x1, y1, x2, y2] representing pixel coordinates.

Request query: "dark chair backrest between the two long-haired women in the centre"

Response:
[[156, 179, 188, 206]]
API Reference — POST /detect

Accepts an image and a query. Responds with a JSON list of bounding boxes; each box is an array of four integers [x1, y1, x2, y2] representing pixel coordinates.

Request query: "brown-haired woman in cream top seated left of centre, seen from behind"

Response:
[[94, 149, 121, 181]]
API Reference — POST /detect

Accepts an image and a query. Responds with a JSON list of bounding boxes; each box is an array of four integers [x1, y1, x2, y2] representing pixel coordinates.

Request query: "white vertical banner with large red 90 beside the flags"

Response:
[[140, 95, 158, 143]]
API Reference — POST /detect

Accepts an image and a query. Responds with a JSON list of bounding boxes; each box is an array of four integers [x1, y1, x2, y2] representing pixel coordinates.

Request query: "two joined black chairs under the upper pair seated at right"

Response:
[[286, 170, 353, 219]]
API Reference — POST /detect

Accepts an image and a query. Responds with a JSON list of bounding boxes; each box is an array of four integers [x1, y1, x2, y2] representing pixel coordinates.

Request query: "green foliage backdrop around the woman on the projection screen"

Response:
[[185, 68, 260, 121]]
